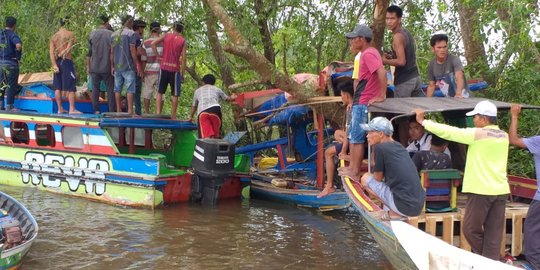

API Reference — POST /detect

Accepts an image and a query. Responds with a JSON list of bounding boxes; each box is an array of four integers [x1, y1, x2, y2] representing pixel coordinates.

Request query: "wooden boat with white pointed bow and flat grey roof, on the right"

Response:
[[341, 98, 540, 269]]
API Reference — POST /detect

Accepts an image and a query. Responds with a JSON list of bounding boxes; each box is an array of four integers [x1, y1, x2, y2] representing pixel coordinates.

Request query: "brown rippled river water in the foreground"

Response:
[[5, 186, 391, 269]]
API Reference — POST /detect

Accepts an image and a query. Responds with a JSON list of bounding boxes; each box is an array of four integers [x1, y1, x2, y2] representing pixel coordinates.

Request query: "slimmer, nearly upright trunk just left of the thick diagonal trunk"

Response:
[[204, 1, 234, 88]]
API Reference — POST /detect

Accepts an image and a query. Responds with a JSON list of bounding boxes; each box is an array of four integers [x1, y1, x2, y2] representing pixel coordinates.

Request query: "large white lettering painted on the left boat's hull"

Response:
[[21, 151, 110, 196]]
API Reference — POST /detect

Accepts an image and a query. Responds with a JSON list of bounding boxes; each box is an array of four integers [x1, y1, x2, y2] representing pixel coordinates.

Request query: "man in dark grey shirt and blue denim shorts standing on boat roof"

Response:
[[112, 15, 143, 114]]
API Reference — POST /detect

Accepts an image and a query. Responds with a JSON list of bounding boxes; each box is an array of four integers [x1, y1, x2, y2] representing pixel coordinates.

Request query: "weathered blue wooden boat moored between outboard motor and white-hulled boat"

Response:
[[236, 89, 350, 211]]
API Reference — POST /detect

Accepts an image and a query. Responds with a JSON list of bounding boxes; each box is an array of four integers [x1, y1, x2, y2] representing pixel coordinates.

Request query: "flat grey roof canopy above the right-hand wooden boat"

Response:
[[369, 97, 540, 117]]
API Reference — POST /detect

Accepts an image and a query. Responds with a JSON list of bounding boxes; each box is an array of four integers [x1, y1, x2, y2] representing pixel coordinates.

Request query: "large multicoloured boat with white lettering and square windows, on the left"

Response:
[[0, 81, 241, 208]]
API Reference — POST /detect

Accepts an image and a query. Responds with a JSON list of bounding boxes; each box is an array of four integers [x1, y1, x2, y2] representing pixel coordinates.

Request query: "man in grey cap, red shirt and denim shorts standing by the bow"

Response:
[[339, 24, 386, 179]]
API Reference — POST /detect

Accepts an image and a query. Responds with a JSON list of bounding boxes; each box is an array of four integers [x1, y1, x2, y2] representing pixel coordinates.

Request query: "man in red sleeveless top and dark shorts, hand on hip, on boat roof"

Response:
[[152, 22, 186, 119]]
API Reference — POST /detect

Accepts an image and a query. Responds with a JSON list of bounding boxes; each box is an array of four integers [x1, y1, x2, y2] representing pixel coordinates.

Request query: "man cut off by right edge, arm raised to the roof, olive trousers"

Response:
[[508, 104, 540, 270]]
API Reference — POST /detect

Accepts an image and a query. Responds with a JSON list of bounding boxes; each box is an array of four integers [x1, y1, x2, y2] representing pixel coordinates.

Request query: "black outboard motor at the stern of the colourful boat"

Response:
[[191, 139, 235, 205]]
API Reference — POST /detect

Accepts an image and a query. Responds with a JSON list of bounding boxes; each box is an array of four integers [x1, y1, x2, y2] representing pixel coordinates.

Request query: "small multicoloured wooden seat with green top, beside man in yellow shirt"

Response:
[[420, 169, 462, 212]]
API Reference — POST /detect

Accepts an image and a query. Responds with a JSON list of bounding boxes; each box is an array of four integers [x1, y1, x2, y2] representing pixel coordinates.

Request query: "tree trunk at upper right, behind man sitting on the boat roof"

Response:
[[457, 0, 493, 83]]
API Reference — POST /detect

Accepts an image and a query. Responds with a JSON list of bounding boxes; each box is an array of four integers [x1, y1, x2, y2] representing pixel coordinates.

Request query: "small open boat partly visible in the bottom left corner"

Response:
[[0, 192, 38, 269]]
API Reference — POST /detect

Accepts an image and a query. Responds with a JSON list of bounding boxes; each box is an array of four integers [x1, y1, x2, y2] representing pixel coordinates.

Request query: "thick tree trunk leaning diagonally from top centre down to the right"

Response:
[[204, 0, 307, 102]]
